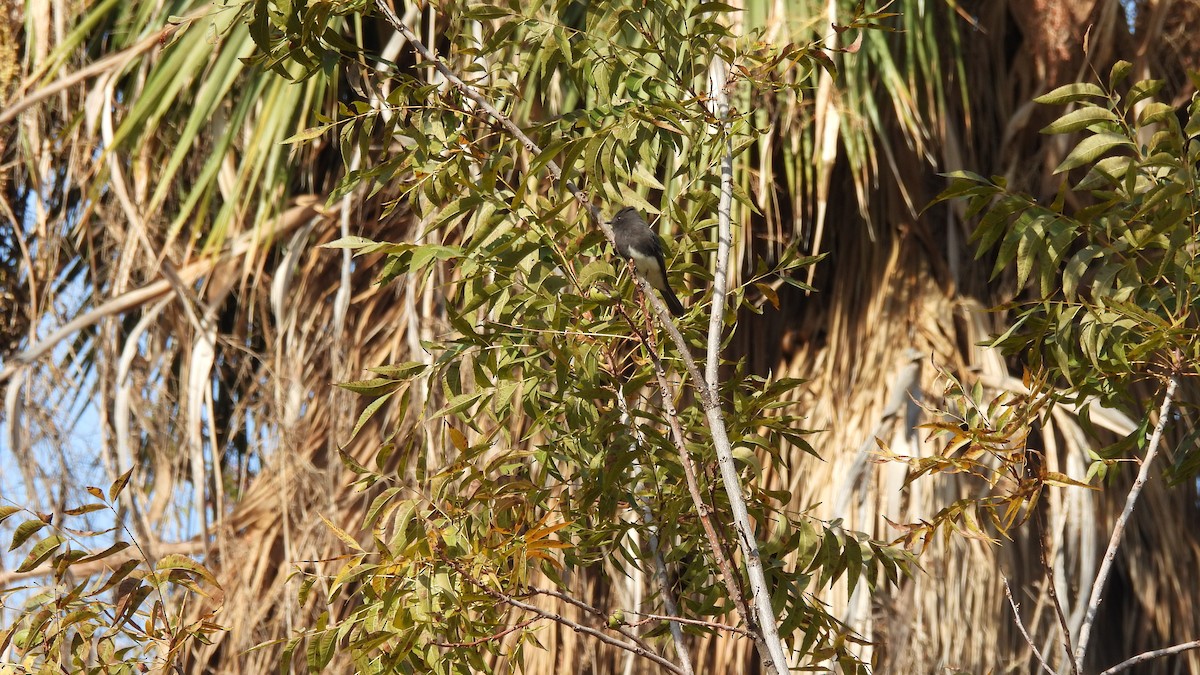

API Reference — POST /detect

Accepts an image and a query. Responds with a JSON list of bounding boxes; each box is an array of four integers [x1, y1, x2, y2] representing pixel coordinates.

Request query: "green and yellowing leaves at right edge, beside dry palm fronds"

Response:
[[884, 61, 1200, 540]]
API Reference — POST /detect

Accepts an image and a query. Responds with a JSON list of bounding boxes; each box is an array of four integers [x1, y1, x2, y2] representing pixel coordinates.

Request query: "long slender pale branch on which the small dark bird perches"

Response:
[[376, 0, 787, 670]]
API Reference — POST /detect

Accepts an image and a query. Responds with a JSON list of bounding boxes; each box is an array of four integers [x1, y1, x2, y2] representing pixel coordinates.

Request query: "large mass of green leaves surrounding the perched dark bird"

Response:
[[246, 2, 908, 673]]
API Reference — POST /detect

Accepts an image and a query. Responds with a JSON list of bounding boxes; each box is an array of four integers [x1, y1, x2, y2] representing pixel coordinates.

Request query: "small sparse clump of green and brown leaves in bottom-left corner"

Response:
[[0, 470, 223, 674]]
